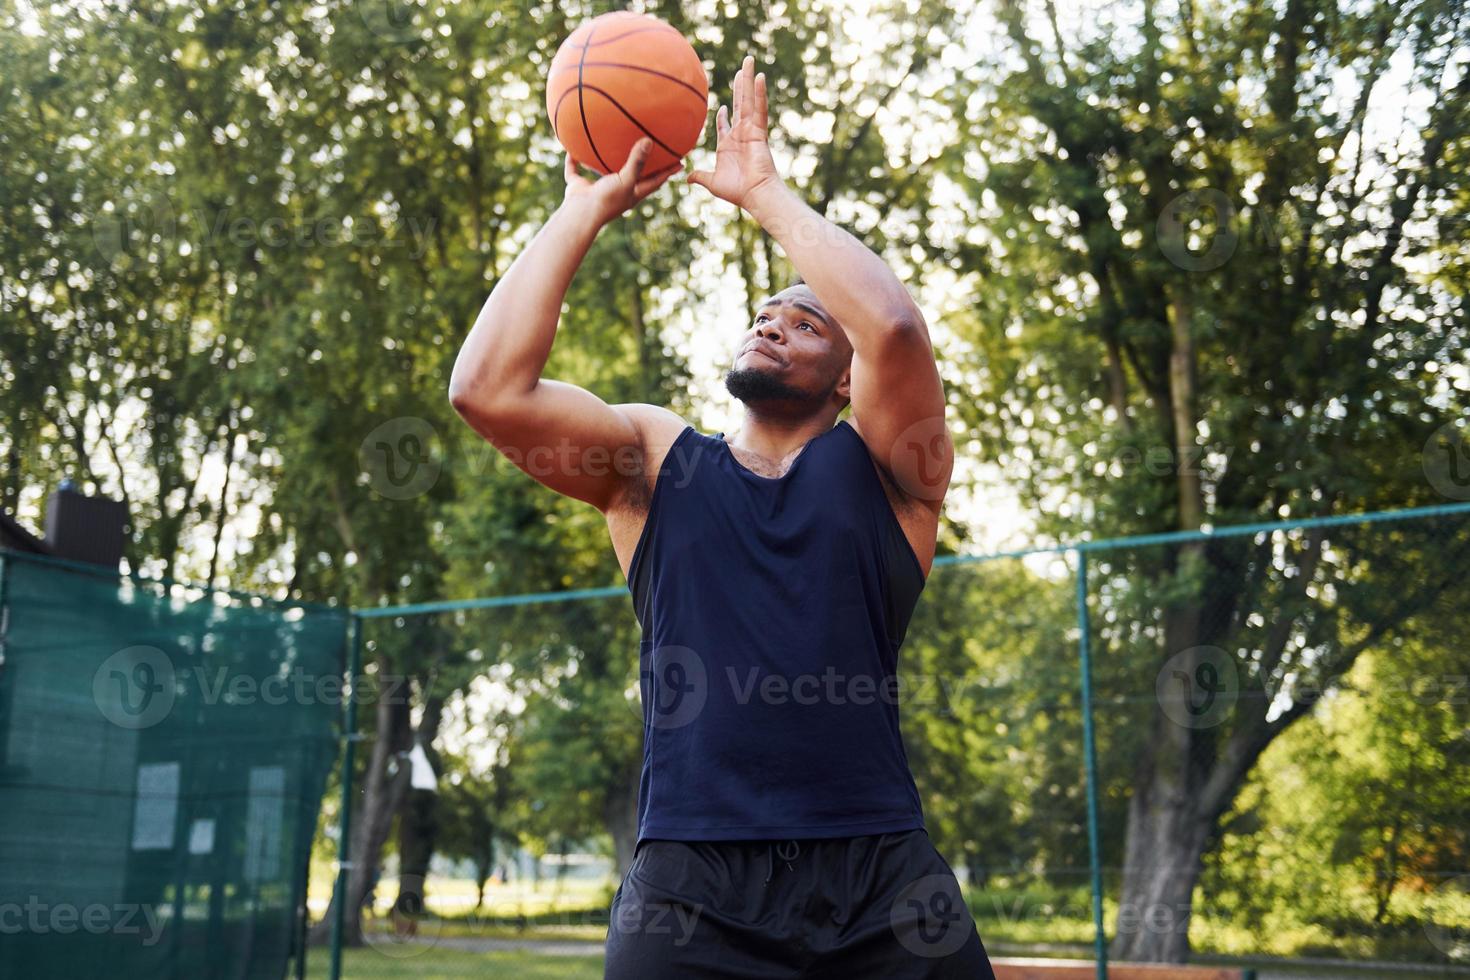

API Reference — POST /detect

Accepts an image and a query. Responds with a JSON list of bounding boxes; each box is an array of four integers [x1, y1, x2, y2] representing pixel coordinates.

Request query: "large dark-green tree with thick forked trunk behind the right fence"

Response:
[[939, 0, 1470, 961]]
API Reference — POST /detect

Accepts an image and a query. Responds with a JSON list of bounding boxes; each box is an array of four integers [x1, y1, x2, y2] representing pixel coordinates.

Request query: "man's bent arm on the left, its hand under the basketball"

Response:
[[450, 140, 672, 511]]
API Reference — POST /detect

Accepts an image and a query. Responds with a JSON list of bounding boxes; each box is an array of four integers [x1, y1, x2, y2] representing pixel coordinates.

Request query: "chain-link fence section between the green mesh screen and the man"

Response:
[[312, 589, 642, 977]]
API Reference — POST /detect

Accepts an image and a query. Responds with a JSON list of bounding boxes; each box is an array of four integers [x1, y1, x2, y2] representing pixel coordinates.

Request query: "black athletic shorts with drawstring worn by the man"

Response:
[[604, 830, 995, 980]]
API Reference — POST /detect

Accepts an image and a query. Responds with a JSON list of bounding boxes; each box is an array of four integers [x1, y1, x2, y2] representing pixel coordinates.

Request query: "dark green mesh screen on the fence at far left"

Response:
[[0, 552, 348, 980]]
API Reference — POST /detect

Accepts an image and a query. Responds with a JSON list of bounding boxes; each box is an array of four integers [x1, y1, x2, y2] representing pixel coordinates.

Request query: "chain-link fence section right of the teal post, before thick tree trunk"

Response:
[[1083, 511, 1470, 964]]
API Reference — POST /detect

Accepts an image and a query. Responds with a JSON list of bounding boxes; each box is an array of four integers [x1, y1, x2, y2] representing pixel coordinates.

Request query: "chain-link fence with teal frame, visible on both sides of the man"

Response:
[[318, 505, 1470, 977]]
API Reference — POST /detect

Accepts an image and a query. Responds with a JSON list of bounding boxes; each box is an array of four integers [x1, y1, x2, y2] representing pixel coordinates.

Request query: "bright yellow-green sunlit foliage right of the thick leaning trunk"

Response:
[[1204, 610, 1470, 934]]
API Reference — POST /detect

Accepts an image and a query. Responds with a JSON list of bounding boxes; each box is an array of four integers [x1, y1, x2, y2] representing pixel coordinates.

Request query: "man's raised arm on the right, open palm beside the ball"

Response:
[[688, 57, 954, 511]]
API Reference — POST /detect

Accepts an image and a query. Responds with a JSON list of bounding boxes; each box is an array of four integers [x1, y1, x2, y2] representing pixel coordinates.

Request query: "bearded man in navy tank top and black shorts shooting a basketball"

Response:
[[450, 57, 994, 980]]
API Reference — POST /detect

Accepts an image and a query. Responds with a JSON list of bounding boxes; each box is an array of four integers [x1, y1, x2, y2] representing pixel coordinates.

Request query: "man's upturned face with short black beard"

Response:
[[725, 285, 853, 407]]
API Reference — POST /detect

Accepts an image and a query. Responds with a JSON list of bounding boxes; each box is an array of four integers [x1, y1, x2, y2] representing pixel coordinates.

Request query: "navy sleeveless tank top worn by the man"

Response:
[[628, 420, 925, 840]]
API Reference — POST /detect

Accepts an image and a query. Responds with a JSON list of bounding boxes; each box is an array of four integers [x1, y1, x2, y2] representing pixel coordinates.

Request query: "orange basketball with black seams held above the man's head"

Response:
[[547, 10, 710, 178]]
